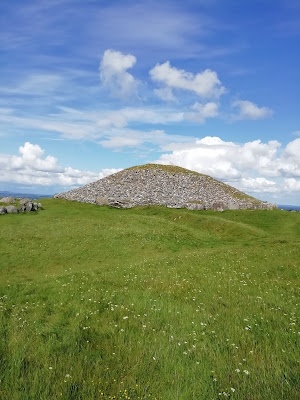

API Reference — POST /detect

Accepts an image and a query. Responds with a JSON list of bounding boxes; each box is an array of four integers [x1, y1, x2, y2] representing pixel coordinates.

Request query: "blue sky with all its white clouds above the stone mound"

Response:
[[0, 0, 300, 205]]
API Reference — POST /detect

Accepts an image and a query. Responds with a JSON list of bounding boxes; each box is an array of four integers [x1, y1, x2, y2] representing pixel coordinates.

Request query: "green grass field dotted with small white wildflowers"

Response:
[[0, 199, 300, 400]]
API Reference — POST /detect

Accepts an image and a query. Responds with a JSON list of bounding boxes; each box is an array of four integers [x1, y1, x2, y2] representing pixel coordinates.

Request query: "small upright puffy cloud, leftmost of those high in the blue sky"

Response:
[[99, 50, 138, 98]]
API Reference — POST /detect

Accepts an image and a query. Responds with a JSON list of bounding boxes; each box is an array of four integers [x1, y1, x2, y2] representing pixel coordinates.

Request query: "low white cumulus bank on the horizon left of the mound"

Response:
[[0, 142, 119, 186]]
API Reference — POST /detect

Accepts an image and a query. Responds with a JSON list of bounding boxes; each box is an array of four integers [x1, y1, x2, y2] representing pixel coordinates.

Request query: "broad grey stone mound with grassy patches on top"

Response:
[[54, 164, 275, 211]]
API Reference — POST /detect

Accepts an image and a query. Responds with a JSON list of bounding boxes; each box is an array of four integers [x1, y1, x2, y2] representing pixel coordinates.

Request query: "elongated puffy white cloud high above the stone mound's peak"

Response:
[[150, 61, 225, 98]]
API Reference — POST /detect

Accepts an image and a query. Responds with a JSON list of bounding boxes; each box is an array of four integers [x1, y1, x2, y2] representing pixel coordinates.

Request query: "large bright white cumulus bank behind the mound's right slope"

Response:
[[158, 136, 300, 193]]
